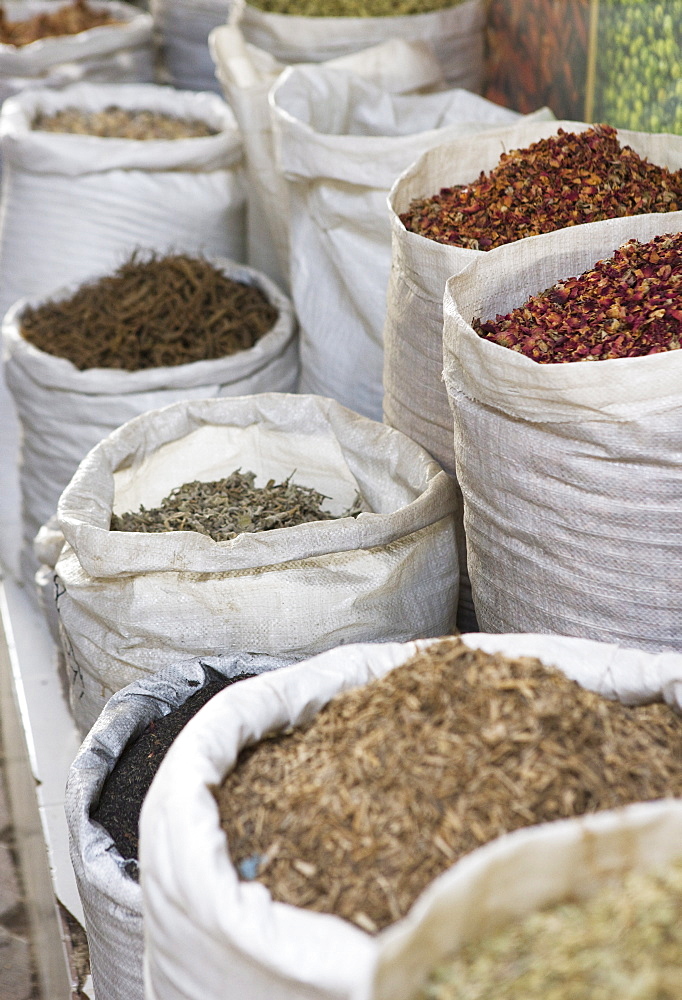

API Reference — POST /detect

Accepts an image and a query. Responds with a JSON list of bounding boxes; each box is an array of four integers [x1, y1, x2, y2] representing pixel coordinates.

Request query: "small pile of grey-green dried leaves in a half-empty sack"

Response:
[[111, 469, 360, 542]]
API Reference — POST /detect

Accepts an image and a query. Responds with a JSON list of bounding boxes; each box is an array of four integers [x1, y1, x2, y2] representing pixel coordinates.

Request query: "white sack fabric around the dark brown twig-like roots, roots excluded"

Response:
[[2, 258, 298, 581]]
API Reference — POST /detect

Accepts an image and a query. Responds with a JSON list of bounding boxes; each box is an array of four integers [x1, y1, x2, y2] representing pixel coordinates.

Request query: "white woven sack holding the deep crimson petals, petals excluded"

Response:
[[444, 212, 682, 651]]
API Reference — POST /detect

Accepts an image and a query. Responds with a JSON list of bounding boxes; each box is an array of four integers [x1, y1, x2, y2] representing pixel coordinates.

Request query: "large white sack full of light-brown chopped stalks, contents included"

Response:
[[140, 634, 682, 1000]]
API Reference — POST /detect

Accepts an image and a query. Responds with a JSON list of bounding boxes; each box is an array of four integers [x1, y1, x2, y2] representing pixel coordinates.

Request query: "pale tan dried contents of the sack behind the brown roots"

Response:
[[32, 105, 216, 140]]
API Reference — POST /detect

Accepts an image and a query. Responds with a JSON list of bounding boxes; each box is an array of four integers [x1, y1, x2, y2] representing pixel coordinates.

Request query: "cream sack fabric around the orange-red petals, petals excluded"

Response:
[[384, 119, 682, 631]]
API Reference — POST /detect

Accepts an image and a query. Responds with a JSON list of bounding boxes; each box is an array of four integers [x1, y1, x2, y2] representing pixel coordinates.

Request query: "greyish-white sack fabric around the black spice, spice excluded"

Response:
[[64, 653, 285, 1000]]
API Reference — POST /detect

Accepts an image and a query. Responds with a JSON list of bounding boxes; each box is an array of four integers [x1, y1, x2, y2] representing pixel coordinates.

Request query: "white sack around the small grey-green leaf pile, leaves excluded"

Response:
[[56, 393, 458, 726]]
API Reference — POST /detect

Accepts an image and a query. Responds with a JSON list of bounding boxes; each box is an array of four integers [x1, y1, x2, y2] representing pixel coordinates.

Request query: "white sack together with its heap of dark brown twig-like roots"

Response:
[[2, 253, 298, 579]]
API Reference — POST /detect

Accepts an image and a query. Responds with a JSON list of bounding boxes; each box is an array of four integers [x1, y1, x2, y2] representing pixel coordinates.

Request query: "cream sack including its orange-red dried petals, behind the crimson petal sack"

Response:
[[384, 121, 682, 631]]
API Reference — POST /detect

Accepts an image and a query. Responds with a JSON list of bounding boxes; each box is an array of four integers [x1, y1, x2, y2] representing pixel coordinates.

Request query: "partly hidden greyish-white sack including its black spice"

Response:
[[64, 653, 286, 1000]]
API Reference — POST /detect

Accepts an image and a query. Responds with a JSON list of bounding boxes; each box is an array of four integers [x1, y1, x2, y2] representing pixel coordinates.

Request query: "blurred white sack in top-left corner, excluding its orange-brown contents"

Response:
[[0, 0, 154, 102]]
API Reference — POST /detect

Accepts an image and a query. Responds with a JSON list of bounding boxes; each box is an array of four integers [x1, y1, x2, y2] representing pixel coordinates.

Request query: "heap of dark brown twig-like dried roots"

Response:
[[21, 253, 278, 371]]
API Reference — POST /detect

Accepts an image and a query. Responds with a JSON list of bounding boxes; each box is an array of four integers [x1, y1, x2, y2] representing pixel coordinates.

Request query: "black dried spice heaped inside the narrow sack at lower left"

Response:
[[91, 666, 254, 880]]
